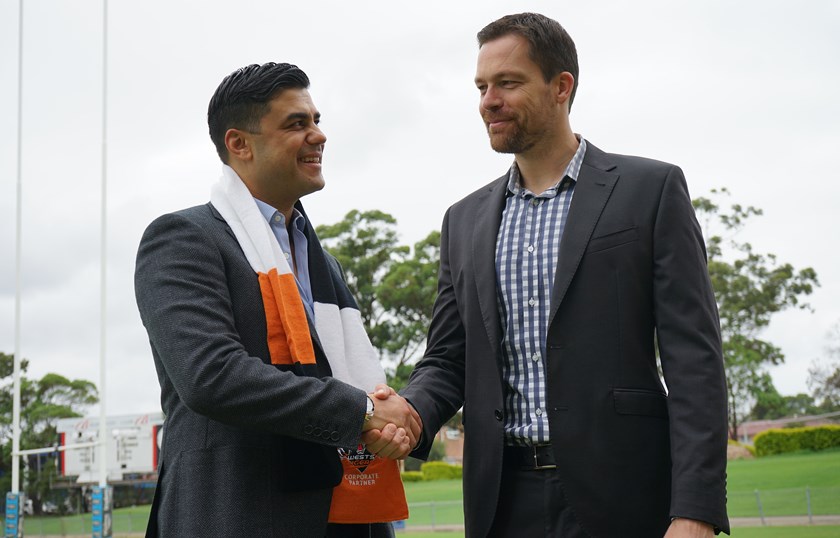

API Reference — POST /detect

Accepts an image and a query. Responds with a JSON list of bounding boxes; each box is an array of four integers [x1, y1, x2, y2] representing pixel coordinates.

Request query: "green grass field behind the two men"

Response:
[[8, 450, 840, 538]]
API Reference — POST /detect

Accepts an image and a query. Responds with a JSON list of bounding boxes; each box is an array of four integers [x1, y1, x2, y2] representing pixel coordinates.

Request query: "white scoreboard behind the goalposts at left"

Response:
[[57, 413, 163, 483]]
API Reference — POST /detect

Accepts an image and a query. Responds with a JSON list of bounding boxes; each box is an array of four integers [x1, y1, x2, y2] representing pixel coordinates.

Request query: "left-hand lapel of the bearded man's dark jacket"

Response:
[[472, 174, 508, 360]]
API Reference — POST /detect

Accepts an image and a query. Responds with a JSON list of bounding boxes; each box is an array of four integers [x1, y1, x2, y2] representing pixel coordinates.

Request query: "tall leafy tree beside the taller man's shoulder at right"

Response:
[[693, 189, 819, 439]]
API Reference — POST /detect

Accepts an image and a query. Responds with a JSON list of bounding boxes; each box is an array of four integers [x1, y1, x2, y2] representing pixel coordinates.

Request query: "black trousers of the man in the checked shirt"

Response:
[[489, 452, 589, 538]]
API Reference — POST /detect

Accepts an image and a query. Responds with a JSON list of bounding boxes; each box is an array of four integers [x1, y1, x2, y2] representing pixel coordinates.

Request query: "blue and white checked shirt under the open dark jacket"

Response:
[[496, 137, 586, 445]]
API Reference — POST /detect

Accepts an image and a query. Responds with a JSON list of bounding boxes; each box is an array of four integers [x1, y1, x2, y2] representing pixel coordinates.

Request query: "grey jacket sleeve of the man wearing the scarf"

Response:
[[135, 214, 366, 446]]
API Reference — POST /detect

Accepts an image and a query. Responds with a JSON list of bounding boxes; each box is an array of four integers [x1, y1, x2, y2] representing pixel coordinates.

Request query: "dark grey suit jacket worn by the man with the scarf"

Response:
[[135, 204, 366, 537]]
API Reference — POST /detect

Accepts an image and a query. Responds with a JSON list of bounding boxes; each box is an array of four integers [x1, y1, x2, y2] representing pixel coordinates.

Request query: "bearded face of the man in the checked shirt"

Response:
[[475, 34, 566, 155]]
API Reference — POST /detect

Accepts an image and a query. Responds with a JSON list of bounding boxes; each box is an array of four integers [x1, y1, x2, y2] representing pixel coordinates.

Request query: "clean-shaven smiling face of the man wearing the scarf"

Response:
[[239, 88, 327, 207]]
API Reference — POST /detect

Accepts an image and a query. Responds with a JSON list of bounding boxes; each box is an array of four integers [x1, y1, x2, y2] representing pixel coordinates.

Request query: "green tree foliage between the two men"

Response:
[[317, 210, 440, 390]]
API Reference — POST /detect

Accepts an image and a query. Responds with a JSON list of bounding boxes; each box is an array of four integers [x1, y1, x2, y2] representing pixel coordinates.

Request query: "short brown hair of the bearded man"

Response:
[[477, 13, 578, 109]]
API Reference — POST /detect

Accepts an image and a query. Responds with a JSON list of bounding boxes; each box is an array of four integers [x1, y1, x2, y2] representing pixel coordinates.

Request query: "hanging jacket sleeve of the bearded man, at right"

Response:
[[653, 167, 729, 532]]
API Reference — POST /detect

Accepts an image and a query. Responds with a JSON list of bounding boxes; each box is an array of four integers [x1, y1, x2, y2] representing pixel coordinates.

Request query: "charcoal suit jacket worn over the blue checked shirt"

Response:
[[403, 144, 728, 538]]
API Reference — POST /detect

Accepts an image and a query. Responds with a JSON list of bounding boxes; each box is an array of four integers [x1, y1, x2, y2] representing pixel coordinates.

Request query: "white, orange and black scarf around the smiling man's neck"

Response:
[[210, 165, 408, 523]]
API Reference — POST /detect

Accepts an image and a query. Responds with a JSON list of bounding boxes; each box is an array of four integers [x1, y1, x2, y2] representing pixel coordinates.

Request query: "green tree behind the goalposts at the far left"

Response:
[[0, 353, 99, 513]]
